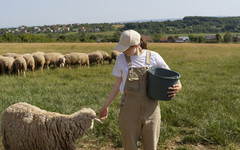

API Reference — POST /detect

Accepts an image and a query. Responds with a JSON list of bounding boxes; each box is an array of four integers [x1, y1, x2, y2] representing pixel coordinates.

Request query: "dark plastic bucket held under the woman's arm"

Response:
[[148, 68, 181, 101]]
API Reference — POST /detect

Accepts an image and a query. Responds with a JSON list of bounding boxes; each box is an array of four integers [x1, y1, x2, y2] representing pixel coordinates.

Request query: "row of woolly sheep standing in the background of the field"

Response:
[[0, 51, 119, 76]]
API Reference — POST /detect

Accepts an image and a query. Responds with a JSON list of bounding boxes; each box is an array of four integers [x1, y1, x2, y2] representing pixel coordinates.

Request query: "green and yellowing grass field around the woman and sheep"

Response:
[[0, 43, 240, 150]]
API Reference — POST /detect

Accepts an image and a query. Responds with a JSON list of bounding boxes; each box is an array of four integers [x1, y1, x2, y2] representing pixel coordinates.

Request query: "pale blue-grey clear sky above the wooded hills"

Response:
[[0, 0, 240, 28]]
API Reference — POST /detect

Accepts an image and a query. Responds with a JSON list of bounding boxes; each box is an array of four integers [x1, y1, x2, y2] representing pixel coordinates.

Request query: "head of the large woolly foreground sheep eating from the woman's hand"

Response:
[[73, 108, 102, 130]]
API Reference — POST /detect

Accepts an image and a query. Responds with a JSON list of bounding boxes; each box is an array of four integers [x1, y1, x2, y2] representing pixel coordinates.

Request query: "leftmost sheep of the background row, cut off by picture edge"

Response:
[[0, 57, 14, 75]]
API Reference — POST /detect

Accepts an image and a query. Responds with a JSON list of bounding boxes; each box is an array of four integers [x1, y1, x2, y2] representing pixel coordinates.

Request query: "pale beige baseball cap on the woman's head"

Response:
[[114, 30, 141, 52]]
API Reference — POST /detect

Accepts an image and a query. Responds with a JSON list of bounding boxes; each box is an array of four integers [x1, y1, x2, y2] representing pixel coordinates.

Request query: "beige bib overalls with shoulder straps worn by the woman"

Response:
[[119, 51, 161, 150]]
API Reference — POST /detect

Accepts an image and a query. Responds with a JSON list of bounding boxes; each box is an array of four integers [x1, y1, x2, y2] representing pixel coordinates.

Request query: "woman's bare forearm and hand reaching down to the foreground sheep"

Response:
[[99, 77, 122, 120]]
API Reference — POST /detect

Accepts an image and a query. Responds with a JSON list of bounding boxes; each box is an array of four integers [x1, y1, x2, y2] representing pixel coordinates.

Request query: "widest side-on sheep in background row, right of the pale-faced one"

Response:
[[64, 52, 89, 67]]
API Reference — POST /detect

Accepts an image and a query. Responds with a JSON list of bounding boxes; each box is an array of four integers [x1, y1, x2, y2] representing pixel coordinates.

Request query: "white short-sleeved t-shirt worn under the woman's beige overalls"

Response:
[[112, 50, 169, 93]]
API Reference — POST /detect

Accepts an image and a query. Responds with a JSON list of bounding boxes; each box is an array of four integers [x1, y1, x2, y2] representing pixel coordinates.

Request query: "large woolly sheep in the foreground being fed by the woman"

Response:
[[1, 102, 101, 150]]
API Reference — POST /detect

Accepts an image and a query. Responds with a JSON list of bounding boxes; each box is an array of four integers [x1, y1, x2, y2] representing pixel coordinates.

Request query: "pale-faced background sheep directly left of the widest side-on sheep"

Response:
[[44, 53, 65, 69]]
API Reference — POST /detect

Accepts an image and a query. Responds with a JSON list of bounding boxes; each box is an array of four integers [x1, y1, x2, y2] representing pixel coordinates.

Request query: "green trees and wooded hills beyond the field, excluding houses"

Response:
[[0, 16, 240, 43]]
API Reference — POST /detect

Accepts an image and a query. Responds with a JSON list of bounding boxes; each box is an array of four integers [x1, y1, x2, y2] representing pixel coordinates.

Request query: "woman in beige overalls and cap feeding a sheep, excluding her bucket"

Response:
[[99, 30, 182, 150]]
